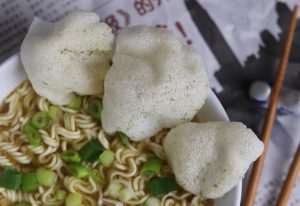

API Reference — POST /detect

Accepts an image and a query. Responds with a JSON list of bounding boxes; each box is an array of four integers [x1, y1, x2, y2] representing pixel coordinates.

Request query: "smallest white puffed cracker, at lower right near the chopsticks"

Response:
[[163, 122, 264, 199]]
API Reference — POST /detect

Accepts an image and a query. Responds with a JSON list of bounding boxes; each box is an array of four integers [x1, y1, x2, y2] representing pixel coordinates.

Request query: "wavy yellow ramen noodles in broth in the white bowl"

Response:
[[0, 81, 212, 206]]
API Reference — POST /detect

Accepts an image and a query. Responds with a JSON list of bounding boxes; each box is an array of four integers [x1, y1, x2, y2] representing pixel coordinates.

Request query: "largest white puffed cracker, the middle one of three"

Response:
[[101, 26, 208, 141]]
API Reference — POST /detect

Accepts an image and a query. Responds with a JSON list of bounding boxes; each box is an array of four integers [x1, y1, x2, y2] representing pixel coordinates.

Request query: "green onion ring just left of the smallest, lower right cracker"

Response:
[[141, 157, 162, 177]]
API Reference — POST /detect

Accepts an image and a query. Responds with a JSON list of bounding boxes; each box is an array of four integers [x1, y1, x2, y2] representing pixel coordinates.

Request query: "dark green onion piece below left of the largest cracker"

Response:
[[78, 139, 105, 163]]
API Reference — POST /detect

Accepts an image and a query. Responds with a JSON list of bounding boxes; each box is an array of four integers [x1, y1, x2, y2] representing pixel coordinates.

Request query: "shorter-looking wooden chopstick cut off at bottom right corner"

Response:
[[276, 144, 300, 206]]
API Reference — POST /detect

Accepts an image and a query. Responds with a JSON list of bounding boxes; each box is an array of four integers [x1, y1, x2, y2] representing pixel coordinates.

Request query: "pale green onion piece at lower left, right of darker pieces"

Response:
[[36, 167, 57, 187]]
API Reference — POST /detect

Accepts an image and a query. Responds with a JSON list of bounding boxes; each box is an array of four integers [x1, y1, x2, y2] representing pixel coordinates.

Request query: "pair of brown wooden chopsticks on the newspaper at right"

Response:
[[244, 6, 300, 206]]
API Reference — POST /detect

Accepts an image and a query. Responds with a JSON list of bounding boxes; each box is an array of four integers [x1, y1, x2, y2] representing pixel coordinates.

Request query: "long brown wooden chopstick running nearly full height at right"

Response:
[[244, 6, 298, 206]]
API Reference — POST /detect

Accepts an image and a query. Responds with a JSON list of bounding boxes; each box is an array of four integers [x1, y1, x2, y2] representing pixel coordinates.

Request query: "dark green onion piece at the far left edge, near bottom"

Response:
[[0, 166, 22, 190]]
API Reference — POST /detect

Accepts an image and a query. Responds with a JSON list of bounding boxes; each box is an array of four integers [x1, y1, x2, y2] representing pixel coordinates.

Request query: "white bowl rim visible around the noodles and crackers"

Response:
[[0, 54, 242, 206]]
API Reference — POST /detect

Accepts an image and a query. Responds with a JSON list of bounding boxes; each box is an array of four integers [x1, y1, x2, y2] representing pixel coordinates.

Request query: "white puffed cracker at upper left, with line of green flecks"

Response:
[[21, 11, 113, 105]]
